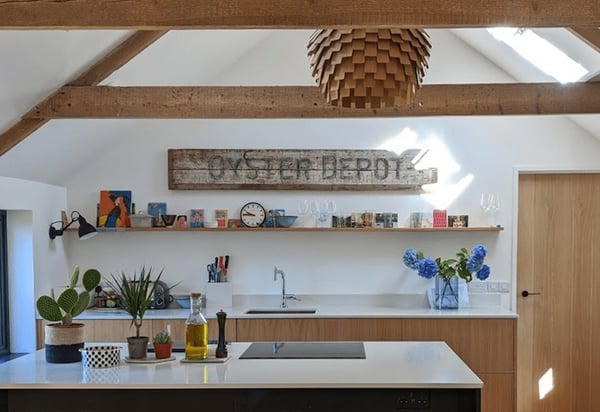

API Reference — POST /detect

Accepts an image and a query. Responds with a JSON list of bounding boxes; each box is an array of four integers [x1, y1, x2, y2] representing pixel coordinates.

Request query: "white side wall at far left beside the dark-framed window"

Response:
[[0, 177, 69, 353]]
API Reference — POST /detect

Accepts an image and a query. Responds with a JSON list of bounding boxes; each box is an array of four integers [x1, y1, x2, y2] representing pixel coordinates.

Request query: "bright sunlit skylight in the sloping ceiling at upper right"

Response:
[[487, 27, 588, 83]]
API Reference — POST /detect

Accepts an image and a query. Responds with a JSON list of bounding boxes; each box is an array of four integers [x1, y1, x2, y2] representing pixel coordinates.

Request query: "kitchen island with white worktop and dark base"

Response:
[[0, 342, 483, 412]]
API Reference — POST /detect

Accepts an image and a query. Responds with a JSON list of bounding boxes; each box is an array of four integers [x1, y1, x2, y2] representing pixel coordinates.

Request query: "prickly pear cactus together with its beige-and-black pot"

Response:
[[36, 266, 102, 363]]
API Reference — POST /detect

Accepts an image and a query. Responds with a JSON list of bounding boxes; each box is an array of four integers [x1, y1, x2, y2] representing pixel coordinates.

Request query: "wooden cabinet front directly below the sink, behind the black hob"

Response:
[[237, 318, 402, 342]]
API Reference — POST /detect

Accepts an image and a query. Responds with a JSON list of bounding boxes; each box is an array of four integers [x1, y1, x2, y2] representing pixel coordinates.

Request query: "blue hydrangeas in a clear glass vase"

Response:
[[403, 245, 490, 309]]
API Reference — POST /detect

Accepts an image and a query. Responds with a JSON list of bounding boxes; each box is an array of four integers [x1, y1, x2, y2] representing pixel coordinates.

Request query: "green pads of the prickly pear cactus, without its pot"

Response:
[[36, 266, 102, 326]]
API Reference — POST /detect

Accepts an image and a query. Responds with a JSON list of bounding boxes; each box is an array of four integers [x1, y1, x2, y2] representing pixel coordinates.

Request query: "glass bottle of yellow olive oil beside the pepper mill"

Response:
[[185, 293, 208, 360]]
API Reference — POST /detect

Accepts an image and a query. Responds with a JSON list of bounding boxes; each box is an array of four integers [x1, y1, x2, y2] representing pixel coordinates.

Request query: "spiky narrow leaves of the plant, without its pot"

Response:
[[106, 266, 163, 338]]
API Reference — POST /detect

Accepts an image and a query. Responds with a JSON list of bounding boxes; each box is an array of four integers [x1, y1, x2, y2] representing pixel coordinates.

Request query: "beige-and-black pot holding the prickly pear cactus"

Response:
[[44, 323, 84, 363]]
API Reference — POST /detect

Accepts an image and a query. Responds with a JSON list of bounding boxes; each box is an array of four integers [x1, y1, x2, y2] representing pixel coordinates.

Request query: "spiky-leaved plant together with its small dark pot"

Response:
[[106, 267, 163, 359]]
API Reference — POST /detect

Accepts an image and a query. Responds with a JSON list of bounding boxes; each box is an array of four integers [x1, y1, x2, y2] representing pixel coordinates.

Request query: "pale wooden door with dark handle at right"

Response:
[[517, 174, 600, 412]]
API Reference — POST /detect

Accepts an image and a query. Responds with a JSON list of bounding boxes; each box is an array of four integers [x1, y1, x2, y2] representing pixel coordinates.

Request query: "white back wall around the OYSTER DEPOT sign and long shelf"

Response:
[[52, 31, 600, 305]]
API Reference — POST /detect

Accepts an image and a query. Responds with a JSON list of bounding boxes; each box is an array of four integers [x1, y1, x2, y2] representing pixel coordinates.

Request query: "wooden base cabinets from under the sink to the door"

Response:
[[237, 318, 516, 412]]
